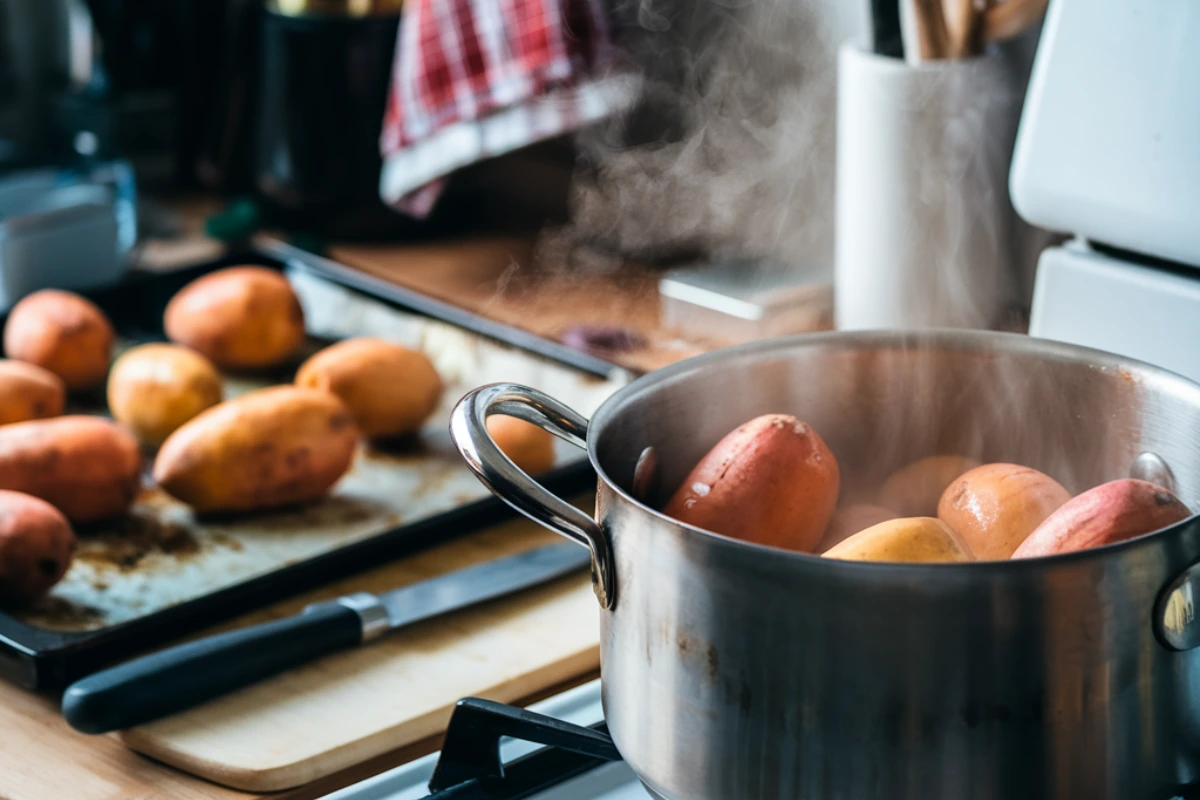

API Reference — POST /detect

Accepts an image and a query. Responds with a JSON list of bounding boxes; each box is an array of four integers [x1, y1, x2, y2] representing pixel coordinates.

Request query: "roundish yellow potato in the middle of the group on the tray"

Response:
[[108, 343, 224, 446]]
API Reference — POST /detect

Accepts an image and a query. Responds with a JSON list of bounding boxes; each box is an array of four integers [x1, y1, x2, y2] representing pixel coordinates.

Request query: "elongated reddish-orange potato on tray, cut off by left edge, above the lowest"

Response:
[[0, 415, 142, 523]]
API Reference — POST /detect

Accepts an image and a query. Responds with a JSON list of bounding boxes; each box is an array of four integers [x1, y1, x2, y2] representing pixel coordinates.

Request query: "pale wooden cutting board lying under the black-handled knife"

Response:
[[116, 521, 600, 792]]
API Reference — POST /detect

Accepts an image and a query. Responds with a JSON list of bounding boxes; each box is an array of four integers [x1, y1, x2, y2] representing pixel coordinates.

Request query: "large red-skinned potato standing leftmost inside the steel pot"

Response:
[[664, 414, 840, 553]]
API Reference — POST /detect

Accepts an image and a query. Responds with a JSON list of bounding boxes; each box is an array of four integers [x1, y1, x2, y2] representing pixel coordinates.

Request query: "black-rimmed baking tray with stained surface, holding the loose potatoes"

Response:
[[0, 254, 626, 688]]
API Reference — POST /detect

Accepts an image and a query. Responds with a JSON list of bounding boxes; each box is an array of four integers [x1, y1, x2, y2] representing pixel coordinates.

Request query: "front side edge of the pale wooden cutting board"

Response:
[[116, 643, 600, 792]]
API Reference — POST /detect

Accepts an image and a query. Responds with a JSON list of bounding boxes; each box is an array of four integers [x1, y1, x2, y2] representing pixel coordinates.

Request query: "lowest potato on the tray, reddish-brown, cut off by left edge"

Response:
[[0, 491, 76, 606]]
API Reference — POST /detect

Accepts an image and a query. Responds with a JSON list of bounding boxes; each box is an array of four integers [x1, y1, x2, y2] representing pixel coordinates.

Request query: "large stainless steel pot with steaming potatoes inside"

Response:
[[451, 332, 1200, 800]]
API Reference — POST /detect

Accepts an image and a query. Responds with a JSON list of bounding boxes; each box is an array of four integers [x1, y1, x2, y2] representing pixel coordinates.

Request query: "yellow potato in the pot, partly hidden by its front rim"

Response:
[[823, 517, 973, 564]]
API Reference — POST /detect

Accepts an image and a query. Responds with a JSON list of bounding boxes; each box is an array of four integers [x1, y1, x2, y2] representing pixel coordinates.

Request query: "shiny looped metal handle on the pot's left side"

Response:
[[450, 384, 616, 610]]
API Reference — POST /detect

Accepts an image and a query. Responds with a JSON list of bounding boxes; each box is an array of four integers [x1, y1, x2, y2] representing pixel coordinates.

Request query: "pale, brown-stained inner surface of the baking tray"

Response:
[[14, 273, 628, 631]]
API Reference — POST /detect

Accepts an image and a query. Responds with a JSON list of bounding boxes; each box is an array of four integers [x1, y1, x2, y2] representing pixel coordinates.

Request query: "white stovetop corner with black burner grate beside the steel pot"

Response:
[[325, 680, 652, 800]]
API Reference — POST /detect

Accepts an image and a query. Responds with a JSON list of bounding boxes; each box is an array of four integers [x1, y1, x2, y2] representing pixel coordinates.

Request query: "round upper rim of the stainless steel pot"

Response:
[[587, 329, 1200, 579]]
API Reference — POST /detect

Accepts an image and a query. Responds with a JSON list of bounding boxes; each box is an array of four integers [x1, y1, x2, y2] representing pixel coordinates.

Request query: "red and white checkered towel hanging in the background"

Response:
[[379, 0, 634, 217]]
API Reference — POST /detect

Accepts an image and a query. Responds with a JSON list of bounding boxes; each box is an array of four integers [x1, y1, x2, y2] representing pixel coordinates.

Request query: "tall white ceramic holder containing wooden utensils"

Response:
[[834, 44, 1031, 329]]
